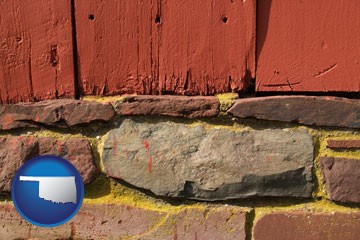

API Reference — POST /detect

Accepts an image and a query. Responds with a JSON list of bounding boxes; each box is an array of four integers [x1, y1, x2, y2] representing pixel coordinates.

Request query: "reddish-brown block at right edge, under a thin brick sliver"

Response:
[[320, 157, 360, 203]]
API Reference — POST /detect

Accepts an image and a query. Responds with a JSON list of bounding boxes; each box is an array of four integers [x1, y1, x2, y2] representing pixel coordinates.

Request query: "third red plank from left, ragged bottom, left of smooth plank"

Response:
[[159, 0, 256, 95]]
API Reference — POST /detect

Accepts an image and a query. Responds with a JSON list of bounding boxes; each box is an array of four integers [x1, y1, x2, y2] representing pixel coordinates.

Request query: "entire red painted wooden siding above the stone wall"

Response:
[[0, 0, 360, 104]]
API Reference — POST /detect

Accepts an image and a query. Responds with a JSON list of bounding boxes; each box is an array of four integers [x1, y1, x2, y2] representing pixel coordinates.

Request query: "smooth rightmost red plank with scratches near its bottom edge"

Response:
[[256, 0, 360, 92]]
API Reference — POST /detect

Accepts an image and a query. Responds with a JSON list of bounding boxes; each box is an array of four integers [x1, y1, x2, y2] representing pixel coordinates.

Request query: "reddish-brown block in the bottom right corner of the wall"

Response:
[[253, 212, 360, 240]]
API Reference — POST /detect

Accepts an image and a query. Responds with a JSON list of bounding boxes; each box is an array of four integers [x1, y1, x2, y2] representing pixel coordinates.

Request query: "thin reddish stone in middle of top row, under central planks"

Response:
[[114, 96, 220, 118]]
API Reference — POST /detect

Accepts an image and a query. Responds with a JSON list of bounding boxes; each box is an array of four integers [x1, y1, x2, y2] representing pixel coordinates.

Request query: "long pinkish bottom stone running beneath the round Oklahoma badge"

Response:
[[0, 203, 246, 240]]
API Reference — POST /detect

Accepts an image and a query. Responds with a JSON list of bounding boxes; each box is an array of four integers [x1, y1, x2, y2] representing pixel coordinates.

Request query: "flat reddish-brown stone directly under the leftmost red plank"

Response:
[[0, 99, 115, 130]]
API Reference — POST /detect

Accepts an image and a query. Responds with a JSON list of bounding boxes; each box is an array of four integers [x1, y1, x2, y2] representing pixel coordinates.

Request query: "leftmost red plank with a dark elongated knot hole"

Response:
[[0, 0, 74, 103]]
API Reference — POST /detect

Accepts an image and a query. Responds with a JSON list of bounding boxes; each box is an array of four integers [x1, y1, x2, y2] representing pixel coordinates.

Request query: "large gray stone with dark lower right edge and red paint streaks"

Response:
[[102, 119, 313, 200]]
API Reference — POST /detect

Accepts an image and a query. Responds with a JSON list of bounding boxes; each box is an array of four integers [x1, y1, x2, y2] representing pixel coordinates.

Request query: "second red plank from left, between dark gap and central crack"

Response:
[[75, 0, 156, 95]]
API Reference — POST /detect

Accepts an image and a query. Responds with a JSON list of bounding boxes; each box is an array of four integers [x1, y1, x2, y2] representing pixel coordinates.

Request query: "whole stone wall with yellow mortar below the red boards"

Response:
[[0, 94, 360, 239]]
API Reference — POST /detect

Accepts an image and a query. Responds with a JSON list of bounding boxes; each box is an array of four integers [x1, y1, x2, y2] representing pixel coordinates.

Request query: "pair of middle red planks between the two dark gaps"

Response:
[[75, 0, 255, 95]]
